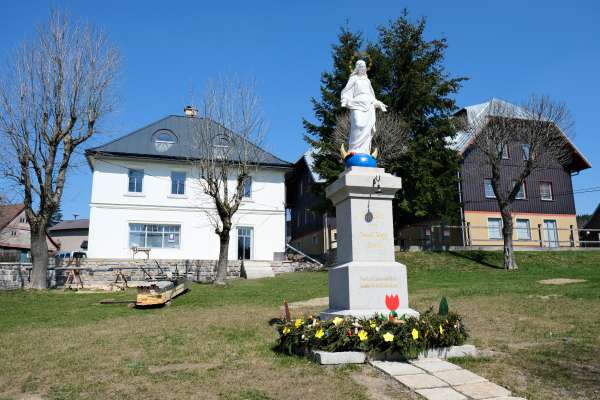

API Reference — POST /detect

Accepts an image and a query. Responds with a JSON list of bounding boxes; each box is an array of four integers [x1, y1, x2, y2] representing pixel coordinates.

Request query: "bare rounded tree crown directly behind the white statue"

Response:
[[333, 112, 408, 168]]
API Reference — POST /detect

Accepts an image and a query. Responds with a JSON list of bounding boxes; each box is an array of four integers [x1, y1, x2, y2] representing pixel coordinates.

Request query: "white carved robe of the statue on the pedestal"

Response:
[[342, 75, 376, 154]]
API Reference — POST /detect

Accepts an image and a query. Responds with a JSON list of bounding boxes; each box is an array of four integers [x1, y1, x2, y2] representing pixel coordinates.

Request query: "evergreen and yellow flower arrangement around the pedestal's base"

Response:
[[275, 310, 468, 359]]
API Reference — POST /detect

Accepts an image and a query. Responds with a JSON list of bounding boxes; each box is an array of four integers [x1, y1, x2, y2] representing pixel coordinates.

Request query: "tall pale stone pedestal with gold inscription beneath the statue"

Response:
[[321, 167, 419, 318]]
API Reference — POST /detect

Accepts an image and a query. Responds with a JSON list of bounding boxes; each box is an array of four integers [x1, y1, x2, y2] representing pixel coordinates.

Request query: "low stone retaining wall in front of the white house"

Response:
[[0, 258, 322, 290]]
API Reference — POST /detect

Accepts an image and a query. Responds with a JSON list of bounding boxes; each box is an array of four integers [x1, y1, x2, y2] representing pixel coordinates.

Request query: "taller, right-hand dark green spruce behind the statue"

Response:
[[375, 10, 467, 223]]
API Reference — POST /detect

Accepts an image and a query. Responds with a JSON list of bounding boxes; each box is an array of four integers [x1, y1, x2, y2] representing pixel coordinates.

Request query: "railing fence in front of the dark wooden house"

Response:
[[397, 223, 600, 250]]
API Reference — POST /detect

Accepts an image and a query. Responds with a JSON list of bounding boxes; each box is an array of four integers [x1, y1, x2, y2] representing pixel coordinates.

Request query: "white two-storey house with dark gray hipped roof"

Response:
[[86, 112, 290, 261]]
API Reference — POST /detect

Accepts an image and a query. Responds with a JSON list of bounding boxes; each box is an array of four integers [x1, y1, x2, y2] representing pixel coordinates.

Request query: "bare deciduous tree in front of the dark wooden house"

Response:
[[468, 96, 572, 270]]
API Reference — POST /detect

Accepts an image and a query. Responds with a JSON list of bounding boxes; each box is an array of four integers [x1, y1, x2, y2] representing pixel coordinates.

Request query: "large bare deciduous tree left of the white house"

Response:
[[0, 12, 119, 289]]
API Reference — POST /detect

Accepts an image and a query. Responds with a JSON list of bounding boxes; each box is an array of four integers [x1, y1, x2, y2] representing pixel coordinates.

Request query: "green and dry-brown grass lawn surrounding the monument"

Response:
[[0, 252, 600, 399]]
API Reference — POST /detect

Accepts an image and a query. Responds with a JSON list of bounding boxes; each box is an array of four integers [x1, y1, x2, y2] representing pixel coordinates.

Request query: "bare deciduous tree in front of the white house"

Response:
[[190, 78, 266, 285]]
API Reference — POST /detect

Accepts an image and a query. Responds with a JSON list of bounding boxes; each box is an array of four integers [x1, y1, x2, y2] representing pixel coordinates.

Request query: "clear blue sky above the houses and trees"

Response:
[[0, 0, 600, 218]]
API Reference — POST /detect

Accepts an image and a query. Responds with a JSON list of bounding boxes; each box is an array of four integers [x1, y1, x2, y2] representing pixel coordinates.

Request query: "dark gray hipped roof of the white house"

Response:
[[86, 115, 291, 167]]
